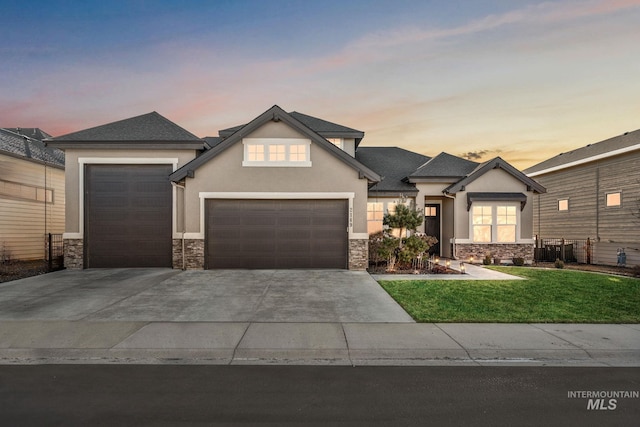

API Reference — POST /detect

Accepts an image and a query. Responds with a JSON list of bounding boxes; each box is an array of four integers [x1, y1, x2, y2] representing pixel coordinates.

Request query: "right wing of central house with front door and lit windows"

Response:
[[356, 147, 545, 261]]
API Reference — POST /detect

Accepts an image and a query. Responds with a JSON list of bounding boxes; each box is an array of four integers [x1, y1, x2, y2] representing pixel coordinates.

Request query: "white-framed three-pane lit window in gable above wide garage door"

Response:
[[242, 138, 311, 167]]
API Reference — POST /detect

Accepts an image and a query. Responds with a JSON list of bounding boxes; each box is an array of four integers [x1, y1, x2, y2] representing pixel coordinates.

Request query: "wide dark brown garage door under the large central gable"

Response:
[[205, 199, 348, 269]]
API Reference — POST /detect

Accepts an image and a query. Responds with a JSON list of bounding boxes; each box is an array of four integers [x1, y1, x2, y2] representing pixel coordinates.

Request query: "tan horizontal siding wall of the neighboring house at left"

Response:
[[0, 155, 65, 260]]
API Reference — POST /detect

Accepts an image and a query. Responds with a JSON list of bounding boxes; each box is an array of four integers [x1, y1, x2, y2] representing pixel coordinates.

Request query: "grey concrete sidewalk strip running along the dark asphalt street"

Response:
[[0, 320, 640, 367]]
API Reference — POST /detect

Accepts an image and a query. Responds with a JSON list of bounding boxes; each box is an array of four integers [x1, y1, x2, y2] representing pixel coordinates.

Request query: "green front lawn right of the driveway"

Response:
[[380, 267, 640, 323]]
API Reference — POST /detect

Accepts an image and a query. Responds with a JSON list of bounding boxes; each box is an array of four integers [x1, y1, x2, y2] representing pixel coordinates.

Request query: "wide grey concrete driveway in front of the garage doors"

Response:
[[0, 269, 413, 323]]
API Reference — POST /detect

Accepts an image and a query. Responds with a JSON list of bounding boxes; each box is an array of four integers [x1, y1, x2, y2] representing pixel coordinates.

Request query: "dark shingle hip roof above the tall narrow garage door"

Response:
[[50, 111, 203, 142]]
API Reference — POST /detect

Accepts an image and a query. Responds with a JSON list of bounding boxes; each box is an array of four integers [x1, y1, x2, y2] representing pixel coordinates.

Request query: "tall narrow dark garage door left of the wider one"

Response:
[[84, 165, 173, 268]]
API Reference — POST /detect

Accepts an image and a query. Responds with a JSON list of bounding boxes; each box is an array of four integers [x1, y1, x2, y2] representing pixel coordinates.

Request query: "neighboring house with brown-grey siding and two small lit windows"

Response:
[[524, 130, 640, 265]]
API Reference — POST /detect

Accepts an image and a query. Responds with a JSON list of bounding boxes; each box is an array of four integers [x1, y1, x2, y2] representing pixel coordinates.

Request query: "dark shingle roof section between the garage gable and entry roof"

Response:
[[356, 147, 430, 194]]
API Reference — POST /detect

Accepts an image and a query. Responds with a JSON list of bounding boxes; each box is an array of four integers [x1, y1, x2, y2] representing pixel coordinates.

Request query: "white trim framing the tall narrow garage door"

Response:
[[62, 157, 180, 239]]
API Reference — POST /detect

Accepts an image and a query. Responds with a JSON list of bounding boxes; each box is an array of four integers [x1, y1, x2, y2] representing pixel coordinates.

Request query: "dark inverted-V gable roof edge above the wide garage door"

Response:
[[169, 105, 380, 182]]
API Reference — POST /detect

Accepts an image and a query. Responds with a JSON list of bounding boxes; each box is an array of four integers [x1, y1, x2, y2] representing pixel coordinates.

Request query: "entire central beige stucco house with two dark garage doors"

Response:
[[48, 106, 544, 270]]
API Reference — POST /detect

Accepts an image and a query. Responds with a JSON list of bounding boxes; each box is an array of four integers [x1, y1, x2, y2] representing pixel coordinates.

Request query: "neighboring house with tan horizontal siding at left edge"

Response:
[[0, 128, 65, 262]]
